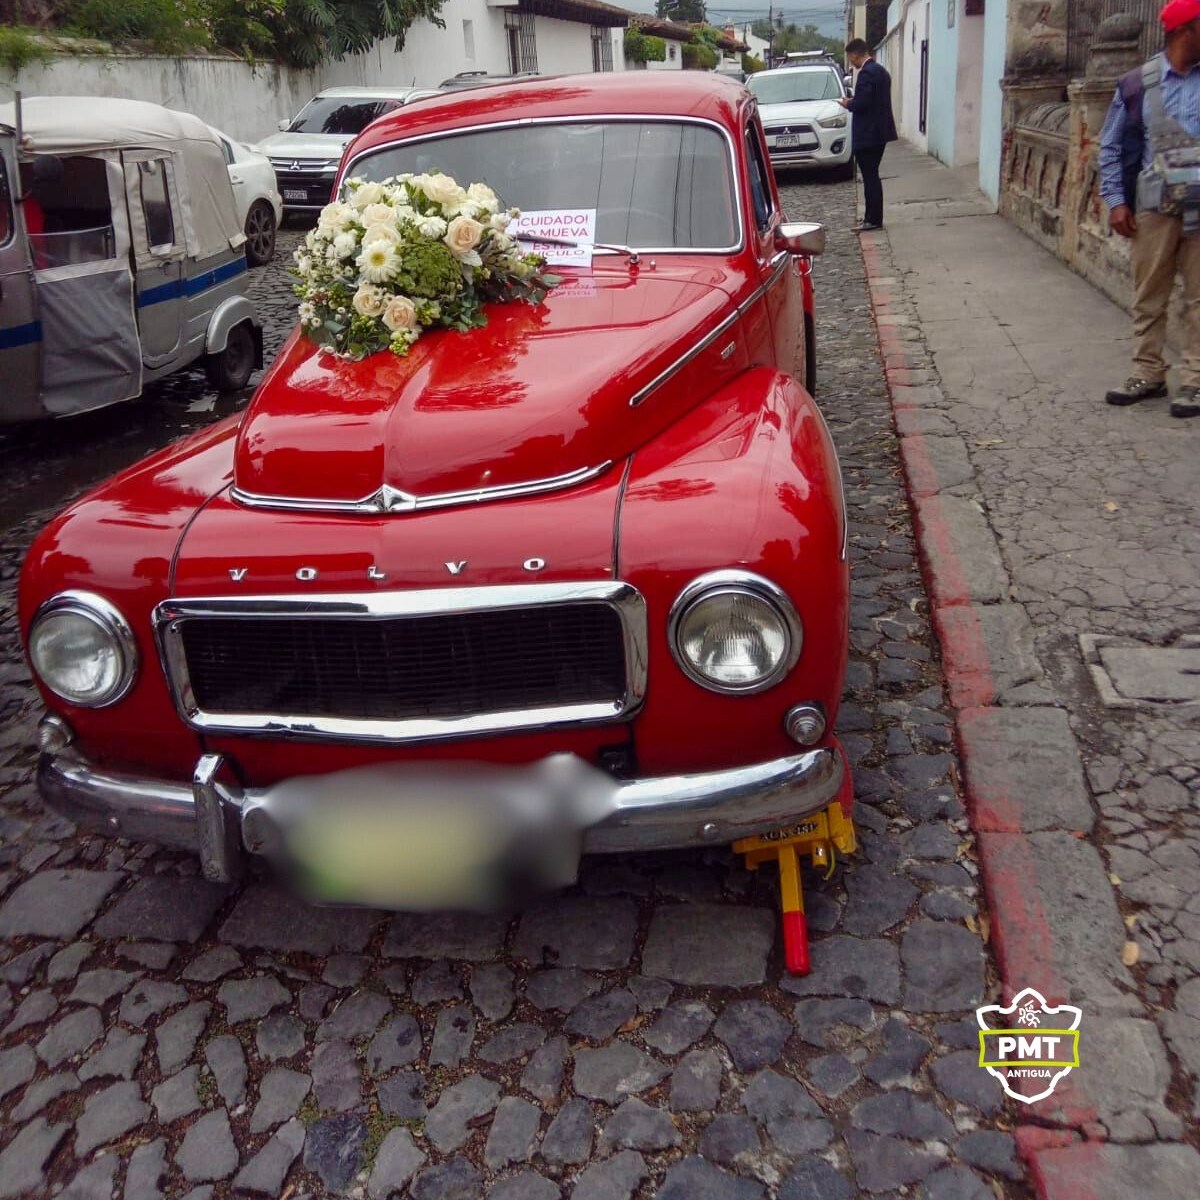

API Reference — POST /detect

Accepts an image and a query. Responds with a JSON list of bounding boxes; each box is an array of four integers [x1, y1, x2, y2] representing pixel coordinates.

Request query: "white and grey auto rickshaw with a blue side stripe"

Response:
[[0, 96, 263, 425]]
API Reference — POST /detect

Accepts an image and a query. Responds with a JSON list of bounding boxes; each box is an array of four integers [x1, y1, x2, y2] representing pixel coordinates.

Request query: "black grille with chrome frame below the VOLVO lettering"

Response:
[[156, 583, 646, 740]]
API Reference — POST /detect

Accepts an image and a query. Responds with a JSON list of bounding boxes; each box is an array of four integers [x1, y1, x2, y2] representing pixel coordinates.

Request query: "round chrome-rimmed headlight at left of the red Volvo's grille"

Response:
[[29, 592, 138, 708]]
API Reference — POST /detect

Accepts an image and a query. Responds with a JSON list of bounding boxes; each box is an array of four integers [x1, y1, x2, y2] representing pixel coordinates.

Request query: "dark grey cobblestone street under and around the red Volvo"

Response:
[[0, 181, 1032, 1200]]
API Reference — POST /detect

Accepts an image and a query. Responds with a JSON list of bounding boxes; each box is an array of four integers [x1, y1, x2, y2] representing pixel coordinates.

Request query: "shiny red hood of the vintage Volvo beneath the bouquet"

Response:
[[235, 263, 745, 503]]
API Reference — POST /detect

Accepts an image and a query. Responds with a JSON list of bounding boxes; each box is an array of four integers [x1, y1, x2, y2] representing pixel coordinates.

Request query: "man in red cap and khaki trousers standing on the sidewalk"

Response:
[[1099, 0, 1200, 418]]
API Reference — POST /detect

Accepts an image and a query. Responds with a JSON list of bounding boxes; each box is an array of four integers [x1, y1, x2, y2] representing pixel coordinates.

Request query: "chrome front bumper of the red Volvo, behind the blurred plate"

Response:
[[37, 746, 845, 880]]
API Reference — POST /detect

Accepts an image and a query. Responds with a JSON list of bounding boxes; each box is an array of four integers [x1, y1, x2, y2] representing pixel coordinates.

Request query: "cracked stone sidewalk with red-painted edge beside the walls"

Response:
[[863, 145, 1200, 1200]]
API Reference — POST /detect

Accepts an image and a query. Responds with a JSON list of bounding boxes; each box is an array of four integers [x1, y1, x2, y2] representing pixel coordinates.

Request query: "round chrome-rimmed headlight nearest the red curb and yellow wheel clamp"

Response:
[[671, 571, 803, 692]]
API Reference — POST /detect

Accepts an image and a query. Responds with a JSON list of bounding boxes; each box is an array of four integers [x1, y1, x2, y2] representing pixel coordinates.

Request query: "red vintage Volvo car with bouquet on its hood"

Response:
[[20, 72, 851, 945]]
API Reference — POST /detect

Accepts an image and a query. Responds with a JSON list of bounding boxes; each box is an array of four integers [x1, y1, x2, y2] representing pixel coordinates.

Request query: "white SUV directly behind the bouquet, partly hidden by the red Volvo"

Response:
[[254, 88, 438, 212]]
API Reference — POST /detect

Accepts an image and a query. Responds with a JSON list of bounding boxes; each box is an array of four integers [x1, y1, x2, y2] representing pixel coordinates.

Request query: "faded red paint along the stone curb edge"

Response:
[[860, 229, 1100, 1200]]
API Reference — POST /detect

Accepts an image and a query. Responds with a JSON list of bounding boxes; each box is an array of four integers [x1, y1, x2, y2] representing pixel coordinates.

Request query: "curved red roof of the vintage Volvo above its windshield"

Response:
[[349, 71, 750, 163]]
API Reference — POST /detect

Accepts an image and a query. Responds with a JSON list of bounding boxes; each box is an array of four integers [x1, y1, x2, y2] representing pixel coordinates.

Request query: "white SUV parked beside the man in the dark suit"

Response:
[[746, 59, 854, 178]]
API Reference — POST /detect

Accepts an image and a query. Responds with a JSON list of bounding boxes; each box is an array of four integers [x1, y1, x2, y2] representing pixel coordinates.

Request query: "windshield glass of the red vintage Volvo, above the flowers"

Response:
[[350, 120, 740, 250]]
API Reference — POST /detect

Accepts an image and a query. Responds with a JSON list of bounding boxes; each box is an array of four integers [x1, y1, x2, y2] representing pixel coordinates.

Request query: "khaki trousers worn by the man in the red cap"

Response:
[[1129, 210, 1200, 388]]
